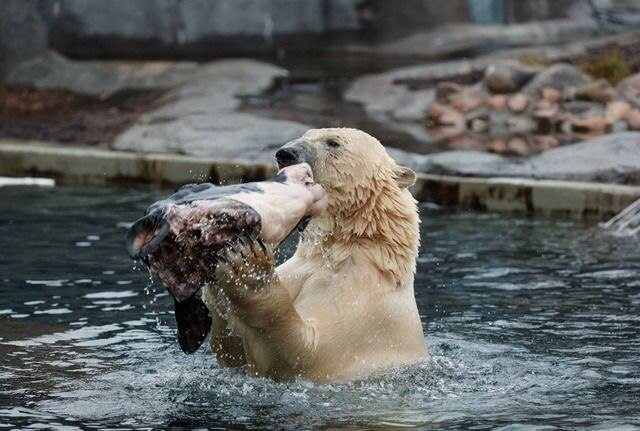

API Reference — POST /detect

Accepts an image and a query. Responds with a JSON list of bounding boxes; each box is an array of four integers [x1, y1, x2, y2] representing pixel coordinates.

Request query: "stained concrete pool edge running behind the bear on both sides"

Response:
[[0, 140, 640, 219]]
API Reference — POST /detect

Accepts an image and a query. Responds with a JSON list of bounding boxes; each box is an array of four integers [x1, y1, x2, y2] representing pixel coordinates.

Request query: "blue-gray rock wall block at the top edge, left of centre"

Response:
[[53, 0, 358, 44]]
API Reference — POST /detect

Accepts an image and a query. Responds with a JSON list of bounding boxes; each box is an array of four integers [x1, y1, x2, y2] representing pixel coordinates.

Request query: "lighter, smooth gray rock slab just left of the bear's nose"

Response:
[[112, 60, 310, 162]]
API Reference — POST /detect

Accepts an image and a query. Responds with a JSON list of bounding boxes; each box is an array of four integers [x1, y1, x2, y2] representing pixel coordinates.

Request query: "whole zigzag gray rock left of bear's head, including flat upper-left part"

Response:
[[3, 53, 310, 162]]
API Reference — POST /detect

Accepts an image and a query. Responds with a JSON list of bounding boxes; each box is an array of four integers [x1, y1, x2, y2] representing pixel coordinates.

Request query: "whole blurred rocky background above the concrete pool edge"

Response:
[[0, 0, 640, 178]]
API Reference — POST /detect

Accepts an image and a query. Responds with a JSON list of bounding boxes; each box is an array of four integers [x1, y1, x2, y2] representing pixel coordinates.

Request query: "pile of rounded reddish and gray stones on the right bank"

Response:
[[426, 63, 640, 156]]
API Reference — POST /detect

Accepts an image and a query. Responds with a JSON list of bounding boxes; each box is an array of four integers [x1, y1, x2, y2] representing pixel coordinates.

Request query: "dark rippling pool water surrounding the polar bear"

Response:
[[0, 188, 640, 430]]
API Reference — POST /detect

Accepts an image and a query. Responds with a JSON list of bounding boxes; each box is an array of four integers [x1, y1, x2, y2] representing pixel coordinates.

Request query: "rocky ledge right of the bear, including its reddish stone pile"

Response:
[[345, 52, 640, 184]]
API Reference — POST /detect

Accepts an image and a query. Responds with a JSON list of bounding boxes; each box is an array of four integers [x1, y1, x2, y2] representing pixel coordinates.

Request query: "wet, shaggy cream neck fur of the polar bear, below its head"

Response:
[[298, 176, 420, 287]]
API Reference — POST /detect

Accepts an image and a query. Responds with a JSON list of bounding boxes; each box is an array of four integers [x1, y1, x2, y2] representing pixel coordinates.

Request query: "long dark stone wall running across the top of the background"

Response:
[[0, 0, 580, 71]]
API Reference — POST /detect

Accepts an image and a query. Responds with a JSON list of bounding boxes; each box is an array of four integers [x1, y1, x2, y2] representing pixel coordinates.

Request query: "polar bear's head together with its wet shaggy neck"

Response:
[[276, 128, 420, 286]]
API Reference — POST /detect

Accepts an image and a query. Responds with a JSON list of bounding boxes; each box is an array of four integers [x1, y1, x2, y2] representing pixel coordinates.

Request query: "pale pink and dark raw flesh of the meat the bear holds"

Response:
[[142, 163, 327, 302]]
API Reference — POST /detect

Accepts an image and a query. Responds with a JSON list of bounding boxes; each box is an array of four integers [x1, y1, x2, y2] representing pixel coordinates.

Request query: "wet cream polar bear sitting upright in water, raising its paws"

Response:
[[203, 128, 428, 382]]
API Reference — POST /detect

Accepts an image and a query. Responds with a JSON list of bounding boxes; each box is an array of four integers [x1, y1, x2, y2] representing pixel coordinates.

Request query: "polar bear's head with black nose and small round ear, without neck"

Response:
[[276, 128, 416, 196]]
